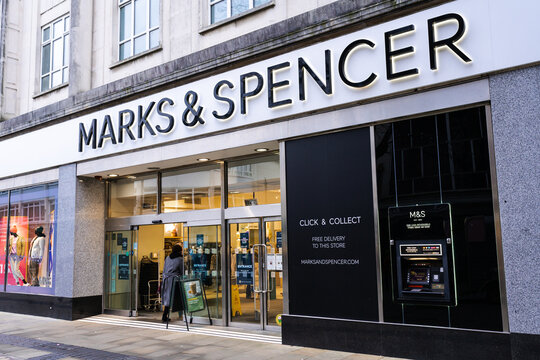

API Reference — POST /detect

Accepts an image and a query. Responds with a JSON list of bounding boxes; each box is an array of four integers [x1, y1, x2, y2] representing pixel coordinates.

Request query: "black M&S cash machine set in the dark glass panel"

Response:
[[388, 204, 457, 306]]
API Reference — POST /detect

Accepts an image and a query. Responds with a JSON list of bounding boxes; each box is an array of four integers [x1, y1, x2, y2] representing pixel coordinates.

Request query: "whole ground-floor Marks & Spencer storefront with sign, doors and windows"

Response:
[[0, 0, 540, 359]]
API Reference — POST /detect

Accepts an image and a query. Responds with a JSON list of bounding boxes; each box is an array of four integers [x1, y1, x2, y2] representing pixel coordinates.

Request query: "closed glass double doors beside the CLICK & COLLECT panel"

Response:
[[229, 219, 283, 329]]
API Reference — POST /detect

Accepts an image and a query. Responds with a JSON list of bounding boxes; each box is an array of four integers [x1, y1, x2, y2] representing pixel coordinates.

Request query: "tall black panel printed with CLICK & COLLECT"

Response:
[[285, 128, 378, 320]]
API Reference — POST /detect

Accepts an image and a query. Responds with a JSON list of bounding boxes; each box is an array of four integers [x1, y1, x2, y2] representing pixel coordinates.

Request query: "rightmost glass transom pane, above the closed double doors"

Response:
[[227, 155, 281, 207]]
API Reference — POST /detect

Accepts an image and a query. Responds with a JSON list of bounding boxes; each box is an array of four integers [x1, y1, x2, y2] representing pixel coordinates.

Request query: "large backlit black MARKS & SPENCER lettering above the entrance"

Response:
[[78, 13, 472, 152]]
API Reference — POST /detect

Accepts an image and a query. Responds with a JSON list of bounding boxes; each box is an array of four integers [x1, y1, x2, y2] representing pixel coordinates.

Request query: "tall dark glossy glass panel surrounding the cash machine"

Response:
[[375, 107, 502, 331]]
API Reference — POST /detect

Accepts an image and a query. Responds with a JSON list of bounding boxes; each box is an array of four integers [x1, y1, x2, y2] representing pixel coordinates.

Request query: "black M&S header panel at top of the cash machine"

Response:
[[388, 204, 452, 240]]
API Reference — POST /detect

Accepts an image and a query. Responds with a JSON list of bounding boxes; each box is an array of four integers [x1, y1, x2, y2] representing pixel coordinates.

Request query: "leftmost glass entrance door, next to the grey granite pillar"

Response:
[[103, 230, 137, 316]]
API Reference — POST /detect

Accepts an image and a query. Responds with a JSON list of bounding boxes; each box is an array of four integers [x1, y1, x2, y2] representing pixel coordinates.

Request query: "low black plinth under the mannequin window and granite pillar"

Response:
[[0, 293, 102, 320]]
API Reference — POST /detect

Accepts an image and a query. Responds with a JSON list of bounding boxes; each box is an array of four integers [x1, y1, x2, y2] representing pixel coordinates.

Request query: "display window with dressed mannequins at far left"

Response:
[[0, 184, 58, 293]]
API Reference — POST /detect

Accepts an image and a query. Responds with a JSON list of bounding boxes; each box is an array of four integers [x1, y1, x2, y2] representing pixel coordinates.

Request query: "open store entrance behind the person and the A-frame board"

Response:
[[104, 223, 222, 323]]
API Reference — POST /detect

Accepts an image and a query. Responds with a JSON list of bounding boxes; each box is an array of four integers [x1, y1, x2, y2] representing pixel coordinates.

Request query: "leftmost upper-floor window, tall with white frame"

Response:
[[40, 15, 70, 91]]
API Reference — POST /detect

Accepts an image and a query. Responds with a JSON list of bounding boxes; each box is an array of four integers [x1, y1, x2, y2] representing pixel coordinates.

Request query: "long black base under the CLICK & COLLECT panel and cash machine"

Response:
[[282, 315, 520, 360]]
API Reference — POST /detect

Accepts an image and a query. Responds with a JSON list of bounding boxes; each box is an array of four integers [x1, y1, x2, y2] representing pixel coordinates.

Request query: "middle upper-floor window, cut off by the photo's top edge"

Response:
[[118, 0, 159, 60]]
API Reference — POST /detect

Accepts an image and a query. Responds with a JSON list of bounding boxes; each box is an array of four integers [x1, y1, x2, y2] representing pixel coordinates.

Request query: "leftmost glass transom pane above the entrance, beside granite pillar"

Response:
[[109, 174, 158, 218]]
